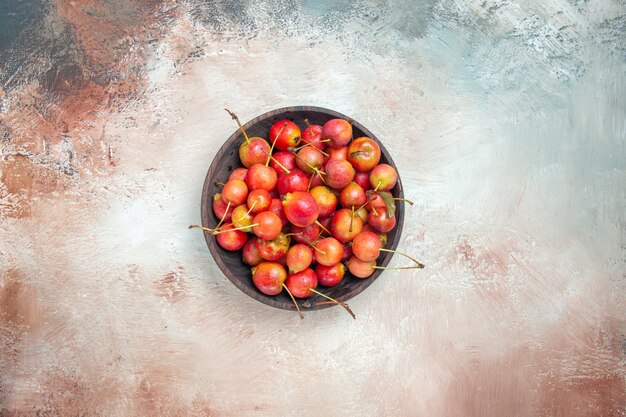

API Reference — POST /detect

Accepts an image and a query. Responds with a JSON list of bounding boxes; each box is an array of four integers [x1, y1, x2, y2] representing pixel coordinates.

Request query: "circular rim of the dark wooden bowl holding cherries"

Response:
[[200, 105, 404, 311]]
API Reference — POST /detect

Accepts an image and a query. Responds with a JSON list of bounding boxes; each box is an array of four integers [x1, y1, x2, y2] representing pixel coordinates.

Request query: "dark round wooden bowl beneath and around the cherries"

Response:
[[201, 106, 404, 310]]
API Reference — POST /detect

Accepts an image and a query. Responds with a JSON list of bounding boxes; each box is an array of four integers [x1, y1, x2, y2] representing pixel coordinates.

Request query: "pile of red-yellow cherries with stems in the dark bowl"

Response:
[[189, 110, 424, 318]]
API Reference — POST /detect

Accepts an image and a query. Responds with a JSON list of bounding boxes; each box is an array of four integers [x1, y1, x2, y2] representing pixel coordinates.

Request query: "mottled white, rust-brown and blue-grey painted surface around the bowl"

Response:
[[0, 0, 626, 417]]
